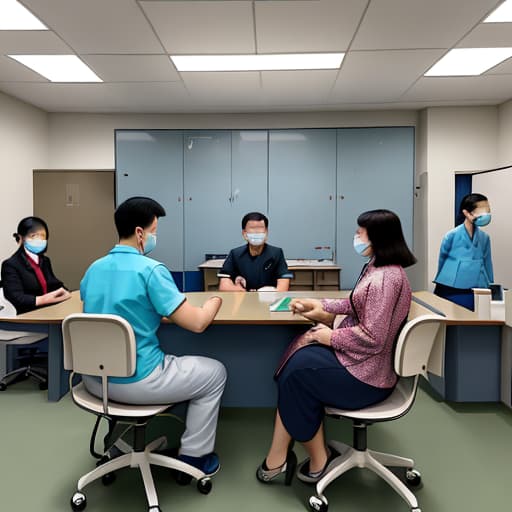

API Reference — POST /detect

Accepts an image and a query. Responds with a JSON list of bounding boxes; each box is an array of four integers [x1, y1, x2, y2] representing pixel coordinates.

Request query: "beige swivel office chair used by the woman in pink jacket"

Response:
[[309, 315, 443, 512]]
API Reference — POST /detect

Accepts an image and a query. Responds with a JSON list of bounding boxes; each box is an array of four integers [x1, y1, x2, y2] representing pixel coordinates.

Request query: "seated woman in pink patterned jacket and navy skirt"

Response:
[[256, 210, 416, 485]]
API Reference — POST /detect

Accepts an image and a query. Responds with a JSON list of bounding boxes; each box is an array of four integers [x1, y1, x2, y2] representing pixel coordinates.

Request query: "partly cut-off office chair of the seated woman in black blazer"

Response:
[[0, 286, 48, 391]]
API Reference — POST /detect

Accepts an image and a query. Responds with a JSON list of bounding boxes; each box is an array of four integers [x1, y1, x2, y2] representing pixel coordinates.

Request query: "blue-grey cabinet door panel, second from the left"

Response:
[[183, 130, 233, 271]]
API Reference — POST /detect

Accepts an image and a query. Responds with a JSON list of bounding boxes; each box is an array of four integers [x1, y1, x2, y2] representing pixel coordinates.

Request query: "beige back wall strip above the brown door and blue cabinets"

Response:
[[49, 110, 417, 169]]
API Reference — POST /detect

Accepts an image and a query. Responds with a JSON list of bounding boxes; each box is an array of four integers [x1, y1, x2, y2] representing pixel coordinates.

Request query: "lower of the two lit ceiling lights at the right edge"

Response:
[[425, 48, 512, 76]]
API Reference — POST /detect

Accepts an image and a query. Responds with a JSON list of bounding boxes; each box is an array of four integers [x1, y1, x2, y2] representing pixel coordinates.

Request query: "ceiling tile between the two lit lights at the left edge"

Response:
[[0, 30, 72, 54]]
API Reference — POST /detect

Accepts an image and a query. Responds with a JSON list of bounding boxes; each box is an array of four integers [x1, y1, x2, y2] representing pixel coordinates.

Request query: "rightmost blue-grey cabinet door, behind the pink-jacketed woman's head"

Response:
[[337, 127, 414, 289]]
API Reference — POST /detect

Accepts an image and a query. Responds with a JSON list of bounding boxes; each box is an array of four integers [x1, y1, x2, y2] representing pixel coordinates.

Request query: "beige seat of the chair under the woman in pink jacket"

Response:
[[325, 377, 416, 422]]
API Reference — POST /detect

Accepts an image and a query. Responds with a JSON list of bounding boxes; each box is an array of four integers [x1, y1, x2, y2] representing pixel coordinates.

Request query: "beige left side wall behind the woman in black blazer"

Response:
[[0, 93, 48, 261]]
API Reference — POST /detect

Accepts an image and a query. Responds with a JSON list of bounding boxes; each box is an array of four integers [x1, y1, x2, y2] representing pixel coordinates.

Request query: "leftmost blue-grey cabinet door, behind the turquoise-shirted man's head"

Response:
[[116, 130, 183, 271]]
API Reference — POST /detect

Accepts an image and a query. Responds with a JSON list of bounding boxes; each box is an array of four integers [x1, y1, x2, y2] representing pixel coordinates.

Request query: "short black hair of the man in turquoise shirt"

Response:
[[114, 197, 165, 238]]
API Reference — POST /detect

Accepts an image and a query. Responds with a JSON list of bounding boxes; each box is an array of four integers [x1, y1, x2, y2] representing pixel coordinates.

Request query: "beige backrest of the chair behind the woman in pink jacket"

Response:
[[395, 315, 443, 377]]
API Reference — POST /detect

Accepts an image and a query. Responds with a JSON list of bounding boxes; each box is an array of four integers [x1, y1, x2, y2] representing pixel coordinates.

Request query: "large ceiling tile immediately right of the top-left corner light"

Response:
[[23, 0, 163, 53]]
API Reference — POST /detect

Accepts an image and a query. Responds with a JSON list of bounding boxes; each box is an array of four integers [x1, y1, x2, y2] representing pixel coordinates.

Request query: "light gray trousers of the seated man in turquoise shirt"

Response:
[[83, 355, 226, 457]]
